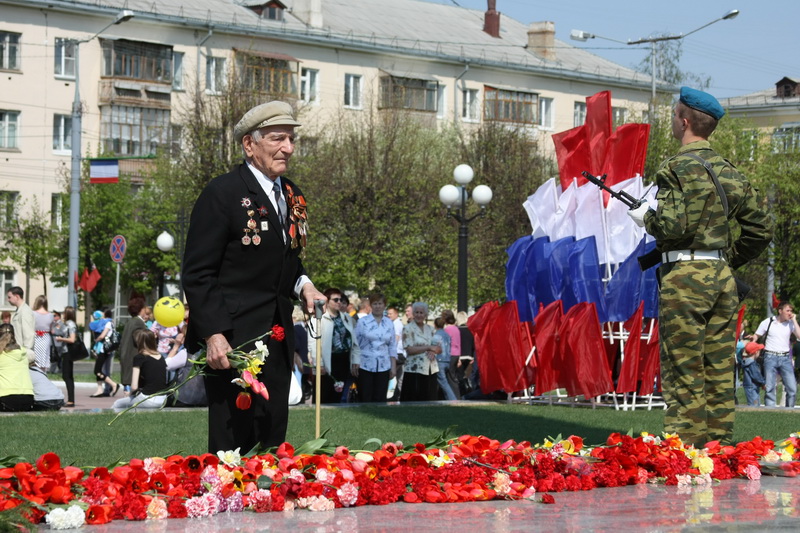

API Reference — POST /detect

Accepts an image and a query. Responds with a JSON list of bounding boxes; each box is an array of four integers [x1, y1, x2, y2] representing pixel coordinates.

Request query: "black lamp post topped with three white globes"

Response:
[[439, 165, 492, 313]]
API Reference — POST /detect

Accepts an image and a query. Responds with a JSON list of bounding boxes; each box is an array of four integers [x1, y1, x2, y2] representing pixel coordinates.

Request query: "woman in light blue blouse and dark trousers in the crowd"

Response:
[[353, 293, 397, 402]]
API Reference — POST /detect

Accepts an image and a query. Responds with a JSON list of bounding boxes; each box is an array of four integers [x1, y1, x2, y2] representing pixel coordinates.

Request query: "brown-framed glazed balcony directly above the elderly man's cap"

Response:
[[238, 52, 297, 97]]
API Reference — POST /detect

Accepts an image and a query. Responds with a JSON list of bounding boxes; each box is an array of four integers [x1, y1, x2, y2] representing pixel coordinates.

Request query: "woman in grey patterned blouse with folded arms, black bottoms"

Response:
[[400, 302, 442, 402]]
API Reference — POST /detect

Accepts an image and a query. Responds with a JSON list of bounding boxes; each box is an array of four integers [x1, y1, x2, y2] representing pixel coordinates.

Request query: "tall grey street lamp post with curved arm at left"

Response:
[[67, 9, 134, 309]]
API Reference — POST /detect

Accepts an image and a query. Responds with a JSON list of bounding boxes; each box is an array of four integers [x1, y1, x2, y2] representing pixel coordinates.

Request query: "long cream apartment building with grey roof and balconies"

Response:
[[0, 0, 671, 309]]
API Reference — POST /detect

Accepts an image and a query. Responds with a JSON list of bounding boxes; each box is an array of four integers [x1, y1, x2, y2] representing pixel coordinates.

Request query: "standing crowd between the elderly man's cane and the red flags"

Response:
[[294, 287, 472, 403]]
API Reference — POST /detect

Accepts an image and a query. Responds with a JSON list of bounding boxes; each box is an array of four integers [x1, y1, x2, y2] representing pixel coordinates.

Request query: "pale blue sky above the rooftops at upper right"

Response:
[[427, 0, 800, 98]]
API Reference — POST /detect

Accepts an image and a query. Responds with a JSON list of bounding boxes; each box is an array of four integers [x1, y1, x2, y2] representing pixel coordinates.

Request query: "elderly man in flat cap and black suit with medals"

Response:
[[183, 101, 325, 453]]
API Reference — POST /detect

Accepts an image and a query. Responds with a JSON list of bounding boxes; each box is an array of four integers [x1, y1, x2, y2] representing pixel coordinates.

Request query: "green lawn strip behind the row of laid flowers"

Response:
[[0, 403, 800, 466]]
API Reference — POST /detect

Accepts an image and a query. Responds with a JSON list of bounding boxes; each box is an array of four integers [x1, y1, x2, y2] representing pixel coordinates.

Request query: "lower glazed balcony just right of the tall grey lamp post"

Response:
[[100, 105, 170, 156]]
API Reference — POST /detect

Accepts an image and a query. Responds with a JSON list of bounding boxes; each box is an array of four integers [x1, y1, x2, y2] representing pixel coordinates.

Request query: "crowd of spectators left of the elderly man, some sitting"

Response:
[[0, 287, 205, 411]]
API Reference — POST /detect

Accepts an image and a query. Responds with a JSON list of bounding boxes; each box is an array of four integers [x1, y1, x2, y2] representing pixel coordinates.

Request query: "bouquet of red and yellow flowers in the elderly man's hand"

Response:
[[108, 326, 286, 426]]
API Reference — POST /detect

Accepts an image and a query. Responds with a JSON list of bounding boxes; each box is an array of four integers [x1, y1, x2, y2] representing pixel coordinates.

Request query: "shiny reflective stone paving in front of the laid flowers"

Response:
[[37, 477, 800, 533]]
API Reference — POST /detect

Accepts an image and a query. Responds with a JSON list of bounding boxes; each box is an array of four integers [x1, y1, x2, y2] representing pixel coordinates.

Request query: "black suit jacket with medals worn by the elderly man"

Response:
[[182, 163, 305, 360]]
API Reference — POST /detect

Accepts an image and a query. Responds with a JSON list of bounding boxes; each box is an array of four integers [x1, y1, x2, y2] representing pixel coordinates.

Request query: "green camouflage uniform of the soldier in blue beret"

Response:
[[644, 141, 772, 446]]
